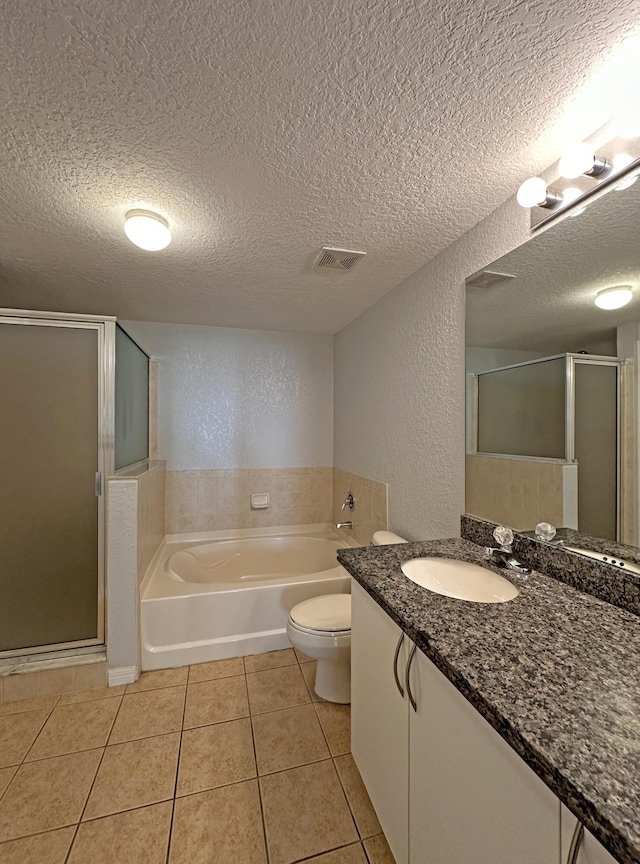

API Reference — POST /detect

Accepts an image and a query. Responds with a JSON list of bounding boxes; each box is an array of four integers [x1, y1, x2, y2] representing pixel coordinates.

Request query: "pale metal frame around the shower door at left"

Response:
[[0, 309, 116, 668]]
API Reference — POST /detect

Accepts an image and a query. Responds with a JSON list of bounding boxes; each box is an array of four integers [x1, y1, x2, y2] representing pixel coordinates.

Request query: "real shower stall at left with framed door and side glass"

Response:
[[0, 309, 148, 667]]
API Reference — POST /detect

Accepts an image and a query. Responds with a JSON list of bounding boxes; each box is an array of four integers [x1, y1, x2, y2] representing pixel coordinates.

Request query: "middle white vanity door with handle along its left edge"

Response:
[[409, 651, 560, 864]]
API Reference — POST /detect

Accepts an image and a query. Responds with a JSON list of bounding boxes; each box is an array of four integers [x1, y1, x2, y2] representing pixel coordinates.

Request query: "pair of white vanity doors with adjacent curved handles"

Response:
[[351, 583, 560, 864]]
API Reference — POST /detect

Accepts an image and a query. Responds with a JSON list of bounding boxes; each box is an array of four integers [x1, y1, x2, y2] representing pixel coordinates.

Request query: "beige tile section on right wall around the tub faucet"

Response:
[[333, 468, 387, 546]]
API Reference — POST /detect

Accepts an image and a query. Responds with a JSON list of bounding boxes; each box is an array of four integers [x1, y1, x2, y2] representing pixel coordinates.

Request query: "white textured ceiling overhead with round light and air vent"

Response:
[[0, 0, 640, 333]]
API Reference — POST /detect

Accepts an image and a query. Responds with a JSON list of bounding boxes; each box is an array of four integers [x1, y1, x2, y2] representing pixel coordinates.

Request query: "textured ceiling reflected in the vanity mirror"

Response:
[[466, 179, 640, 354]]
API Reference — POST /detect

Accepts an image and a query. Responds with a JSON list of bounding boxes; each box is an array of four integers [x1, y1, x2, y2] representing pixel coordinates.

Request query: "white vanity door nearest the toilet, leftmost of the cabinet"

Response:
[[351, 582, 410, 864]]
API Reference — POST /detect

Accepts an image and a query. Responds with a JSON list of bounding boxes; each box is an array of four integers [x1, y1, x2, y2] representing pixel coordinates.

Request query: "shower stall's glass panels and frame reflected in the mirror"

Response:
[[471, 354, 621, 540]]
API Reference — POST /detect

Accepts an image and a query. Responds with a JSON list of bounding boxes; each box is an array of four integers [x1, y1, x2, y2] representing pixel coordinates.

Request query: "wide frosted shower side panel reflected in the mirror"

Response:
[[478, 357, 566, 459]]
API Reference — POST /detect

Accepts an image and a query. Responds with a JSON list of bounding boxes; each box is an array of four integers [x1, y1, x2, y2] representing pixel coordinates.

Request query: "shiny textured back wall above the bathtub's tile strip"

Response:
[[120, 321, 333, 471]]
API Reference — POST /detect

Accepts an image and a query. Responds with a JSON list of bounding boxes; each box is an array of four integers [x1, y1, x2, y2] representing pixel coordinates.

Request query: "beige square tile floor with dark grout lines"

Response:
[[0, 649, 394, 864]]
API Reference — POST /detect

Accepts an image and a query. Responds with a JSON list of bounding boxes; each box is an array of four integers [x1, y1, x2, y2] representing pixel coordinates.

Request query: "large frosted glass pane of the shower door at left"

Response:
[[0, 323, 99, 651]]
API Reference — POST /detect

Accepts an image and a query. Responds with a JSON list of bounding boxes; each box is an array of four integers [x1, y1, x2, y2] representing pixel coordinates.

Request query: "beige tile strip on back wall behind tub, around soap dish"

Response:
[[165, 468, 333, 534]]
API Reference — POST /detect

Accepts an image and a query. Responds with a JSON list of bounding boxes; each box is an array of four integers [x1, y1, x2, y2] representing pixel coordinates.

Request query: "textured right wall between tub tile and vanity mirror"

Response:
[[334, 199, 529, 539]]
